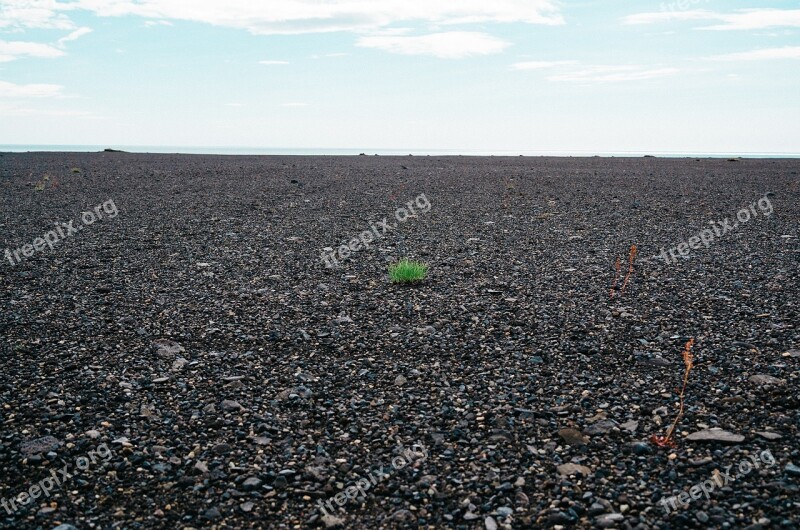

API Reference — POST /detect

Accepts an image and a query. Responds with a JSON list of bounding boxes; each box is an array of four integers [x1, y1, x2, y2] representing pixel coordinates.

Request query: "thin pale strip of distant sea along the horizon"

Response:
[[0, 144, 800, 158]]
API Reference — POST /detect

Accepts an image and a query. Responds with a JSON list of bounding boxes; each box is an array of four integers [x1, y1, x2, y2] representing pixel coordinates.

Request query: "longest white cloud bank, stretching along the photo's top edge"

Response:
[[0, 0, 564, 34]]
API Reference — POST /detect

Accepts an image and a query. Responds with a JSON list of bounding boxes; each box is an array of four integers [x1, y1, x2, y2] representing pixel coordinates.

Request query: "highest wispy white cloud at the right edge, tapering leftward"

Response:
[[623, 9, 800, 30]]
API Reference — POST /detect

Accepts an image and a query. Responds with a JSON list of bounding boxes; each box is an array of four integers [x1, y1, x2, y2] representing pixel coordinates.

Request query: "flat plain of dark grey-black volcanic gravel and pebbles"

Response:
[[0, 153, 800, 530]]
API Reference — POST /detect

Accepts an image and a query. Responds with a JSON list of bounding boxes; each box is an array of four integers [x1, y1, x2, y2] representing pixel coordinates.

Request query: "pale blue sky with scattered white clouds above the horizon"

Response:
[[0, 0, 800, 154]]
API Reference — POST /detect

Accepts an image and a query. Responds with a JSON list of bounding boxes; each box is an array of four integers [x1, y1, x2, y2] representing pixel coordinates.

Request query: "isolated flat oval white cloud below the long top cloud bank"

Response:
[[357, 31, 509, 59]]
